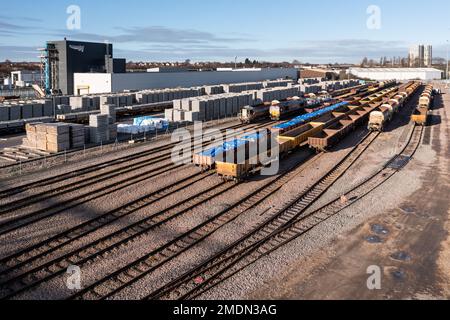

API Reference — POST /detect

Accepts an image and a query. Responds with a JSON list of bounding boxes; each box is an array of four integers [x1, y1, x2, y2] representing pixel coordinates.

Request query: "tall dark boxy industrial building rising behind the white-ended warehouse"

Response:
[[42, 39, 126, 94]]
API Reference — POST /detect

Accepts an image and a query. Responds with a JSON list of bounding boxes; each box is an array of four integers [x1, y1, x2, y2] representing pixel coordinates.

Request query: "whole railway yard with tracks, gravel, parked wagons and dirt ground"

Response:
[[0, 81, 450, 300]]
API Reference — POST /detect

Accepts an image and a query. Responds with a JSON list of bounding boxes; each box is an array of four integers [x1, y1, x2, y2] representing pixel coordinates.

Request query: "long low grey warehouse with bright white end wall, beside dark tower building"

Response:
[[74, 68, 298, 95]]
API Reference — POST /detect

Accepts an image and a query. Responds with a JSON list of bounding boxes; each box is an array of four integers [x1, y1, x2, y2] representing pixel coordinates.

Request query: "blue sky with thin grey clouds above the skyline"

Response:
[[0, 0, 450, 63]]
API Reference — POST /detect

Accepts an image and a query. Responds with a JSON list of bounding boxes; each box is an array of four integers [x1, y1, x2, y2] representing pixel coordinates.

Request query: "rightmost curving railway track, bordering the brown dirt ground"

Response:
[[146, 126, 424, 300]]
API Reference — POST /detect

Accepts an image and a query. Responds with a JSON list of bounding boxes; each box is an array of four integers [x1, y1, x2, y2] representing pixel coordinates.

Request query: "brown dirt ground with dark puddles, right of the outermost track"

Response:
[[250, 85, 450, 300]]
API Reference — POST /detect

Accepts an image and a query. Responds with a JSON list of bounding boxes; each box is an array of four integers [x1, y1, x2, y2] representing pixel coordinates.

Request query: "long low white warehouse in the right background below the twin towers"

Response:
[[348, 68, 443, 81]]
